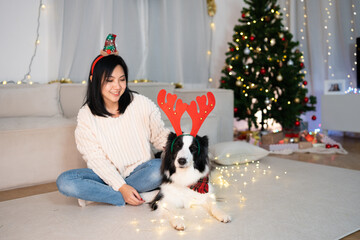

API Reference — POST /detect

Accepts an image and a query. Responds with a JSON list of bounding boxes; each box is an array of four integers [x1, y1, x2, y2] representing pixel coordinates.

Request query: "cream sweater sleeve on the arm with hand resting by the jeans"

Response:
[[75, 109, 125, 191]]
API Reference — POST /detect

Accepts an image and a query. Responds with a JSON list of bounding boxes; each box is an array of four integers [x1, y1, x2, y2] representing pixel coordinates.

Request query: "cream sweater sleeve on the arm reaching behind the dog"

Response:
[[149, 97, 170, 151]]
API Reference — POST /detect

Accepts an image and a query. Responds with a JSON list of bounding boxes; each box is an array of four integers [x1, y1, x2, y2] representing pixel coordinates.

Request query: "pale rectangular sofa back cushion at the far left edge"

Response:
[[0, 83, 62, 117]]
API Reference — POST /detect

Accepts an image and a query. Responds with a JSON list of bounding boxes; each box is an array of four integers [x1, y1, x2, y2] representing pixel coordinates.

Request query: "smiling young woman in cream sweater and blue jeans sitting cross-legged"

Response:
[[56, 55, 169, 206]]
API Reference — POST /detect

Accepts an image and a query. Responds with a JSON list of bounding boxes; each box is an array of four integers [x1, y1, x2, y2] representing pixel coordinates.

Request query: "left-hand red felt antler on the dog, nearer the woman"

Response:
[[157, 89, 188, 136]]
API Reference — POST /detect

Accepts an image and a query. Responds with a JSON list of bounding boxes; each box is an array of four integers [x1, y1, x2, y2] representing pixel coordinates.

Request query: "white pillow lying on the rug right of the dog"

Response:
[[209, 141, 269, 165]]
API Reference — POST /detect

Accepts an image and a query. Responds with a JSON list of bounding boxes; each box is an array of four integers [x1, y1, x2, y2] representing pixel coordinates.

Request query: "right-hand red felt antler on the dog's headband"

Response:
[[186, 92, 215, 137]]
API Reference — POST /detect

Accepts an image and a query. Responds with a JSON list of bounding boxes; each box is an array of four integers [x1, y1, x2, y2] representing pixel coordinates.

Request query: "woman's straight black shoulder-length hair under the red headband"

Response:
[[84, 55, 134, 117]]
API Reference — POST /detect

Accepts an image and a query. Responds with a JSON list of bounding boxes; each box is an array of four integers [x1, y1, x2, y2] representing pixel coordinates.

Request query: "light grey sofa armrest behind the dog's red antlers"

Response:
[[174, 88, 234, 142]]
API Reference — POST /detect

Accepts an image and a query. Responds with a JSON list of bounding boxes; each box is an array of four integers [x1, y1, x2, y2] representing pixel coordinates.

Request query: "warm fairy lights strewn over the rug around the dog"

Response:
[[128, 159, 286, 236]]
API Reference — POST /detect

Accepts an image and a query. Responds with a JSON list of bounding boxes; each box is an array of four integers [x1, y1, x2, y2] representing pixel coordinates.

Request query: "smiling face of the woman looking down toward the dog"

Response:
[[101, 65, 126, 107]]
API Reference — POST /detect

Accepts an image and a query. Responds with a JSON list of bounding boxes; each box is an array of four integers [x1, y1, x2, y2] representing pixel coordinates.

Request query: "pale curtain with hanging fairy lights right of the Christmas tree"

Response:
[[279, 0, 360, 129]]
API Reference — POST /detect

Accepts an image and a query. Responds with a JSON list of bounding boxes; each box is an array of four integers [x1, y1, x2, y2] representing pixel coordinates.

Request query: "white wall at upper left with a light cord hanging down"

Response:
[[0, 0, 61, 82]]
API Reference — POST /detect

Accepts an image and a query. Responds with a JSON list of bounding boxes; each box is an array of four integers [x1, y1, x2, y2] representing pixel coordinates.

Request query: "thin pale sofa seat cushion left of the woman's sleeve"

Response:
[[0, 117, 76, 132]]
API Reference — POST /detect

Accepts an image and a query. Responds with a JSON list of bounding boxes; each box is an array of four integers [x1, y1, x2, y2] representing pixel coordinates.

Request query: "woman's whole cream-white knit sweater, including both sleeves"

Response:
[[75, 93, 170, 191]]
